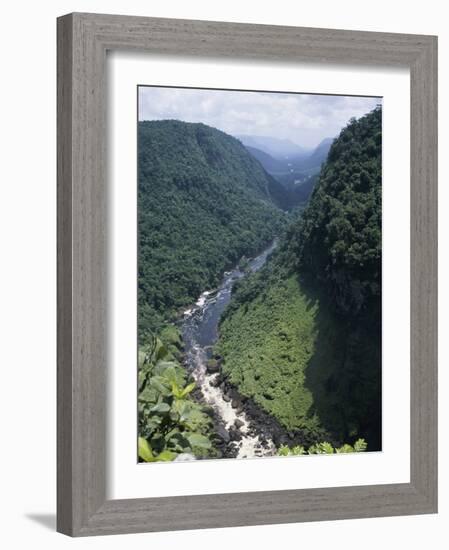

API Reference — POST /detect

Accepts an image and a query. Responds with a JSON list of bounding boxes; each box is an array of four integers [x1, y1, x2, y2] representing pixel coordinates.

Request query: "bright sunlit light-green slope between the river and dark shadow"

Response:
[[215, 269, 323, 437]]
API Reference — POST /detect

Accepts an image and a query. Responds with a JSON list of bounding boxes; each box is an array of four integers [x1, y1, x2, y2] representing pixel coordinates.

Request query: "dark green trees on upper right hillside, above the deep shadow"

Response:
[[287, 108, 382, 321]]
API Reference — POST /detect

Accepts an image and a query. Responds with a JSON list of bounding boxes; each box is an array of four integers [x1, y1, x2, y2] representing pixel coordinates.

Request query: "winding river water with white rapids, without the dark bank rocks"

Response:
[[182, 241, 276, 458]]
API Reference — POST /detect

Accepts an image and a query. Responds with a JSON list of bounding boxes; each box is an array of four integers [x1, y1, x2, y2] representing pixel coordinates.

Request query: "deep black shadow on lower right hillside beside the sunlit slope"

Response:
[[300, 281, 382, 451]]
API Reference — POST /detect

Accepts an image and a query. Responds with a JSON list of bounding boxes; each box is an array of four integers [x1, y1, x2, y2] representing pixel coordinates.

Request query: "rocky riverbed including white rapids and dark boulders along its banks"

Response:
[[178, 243, 312, 458]]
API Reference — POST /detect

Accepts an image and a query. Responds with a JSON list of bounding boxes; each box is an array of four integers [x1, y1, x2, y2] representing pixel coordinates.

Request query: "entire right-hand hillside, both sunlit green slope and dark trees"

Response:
[[216, 108, 382, 450]]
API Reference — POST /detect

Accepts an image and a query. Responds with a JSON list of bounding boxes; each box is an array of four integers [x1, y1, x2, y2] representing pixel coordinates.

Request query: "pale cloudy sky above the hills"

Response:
[[139, 86, 381, 148]]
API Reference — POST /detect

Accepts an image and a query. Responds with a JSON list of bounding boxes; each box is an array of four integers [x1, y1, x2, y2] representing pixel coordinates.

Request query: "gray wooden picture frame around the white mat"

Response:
[[57, 13, 437, 536]]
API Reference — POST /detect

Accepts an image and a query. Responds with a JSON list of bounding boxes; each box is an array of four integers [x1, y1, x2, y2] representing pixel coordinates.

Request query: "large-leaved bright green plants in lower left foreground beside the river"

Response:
[[139, 328, 214, 462]]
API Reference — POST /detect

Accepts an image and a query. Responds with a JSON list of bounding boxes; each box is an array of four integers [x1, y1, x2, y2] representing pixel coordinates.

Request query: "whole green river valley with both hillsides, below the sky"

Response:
[[139, 105, 381, 462]]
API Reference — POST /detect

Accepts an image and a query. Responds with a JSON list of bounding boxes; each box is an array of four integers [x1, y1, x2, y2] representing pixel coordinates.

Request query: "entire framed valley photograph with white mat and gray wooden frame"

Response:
[[57, 13, 437, 536]]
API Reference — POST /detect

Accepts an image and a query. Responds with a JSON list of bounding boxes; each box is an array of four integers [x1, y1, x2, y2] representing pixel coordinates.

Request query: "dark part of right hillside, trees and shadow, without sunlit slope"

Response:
[[281, 108, 382, 449]]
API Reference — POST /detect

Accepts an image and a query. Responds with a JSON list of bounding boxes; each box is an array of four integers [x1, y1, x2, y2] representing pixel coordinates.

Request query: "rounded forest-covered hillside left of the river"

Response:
[[138, 120, 287, 342]]
